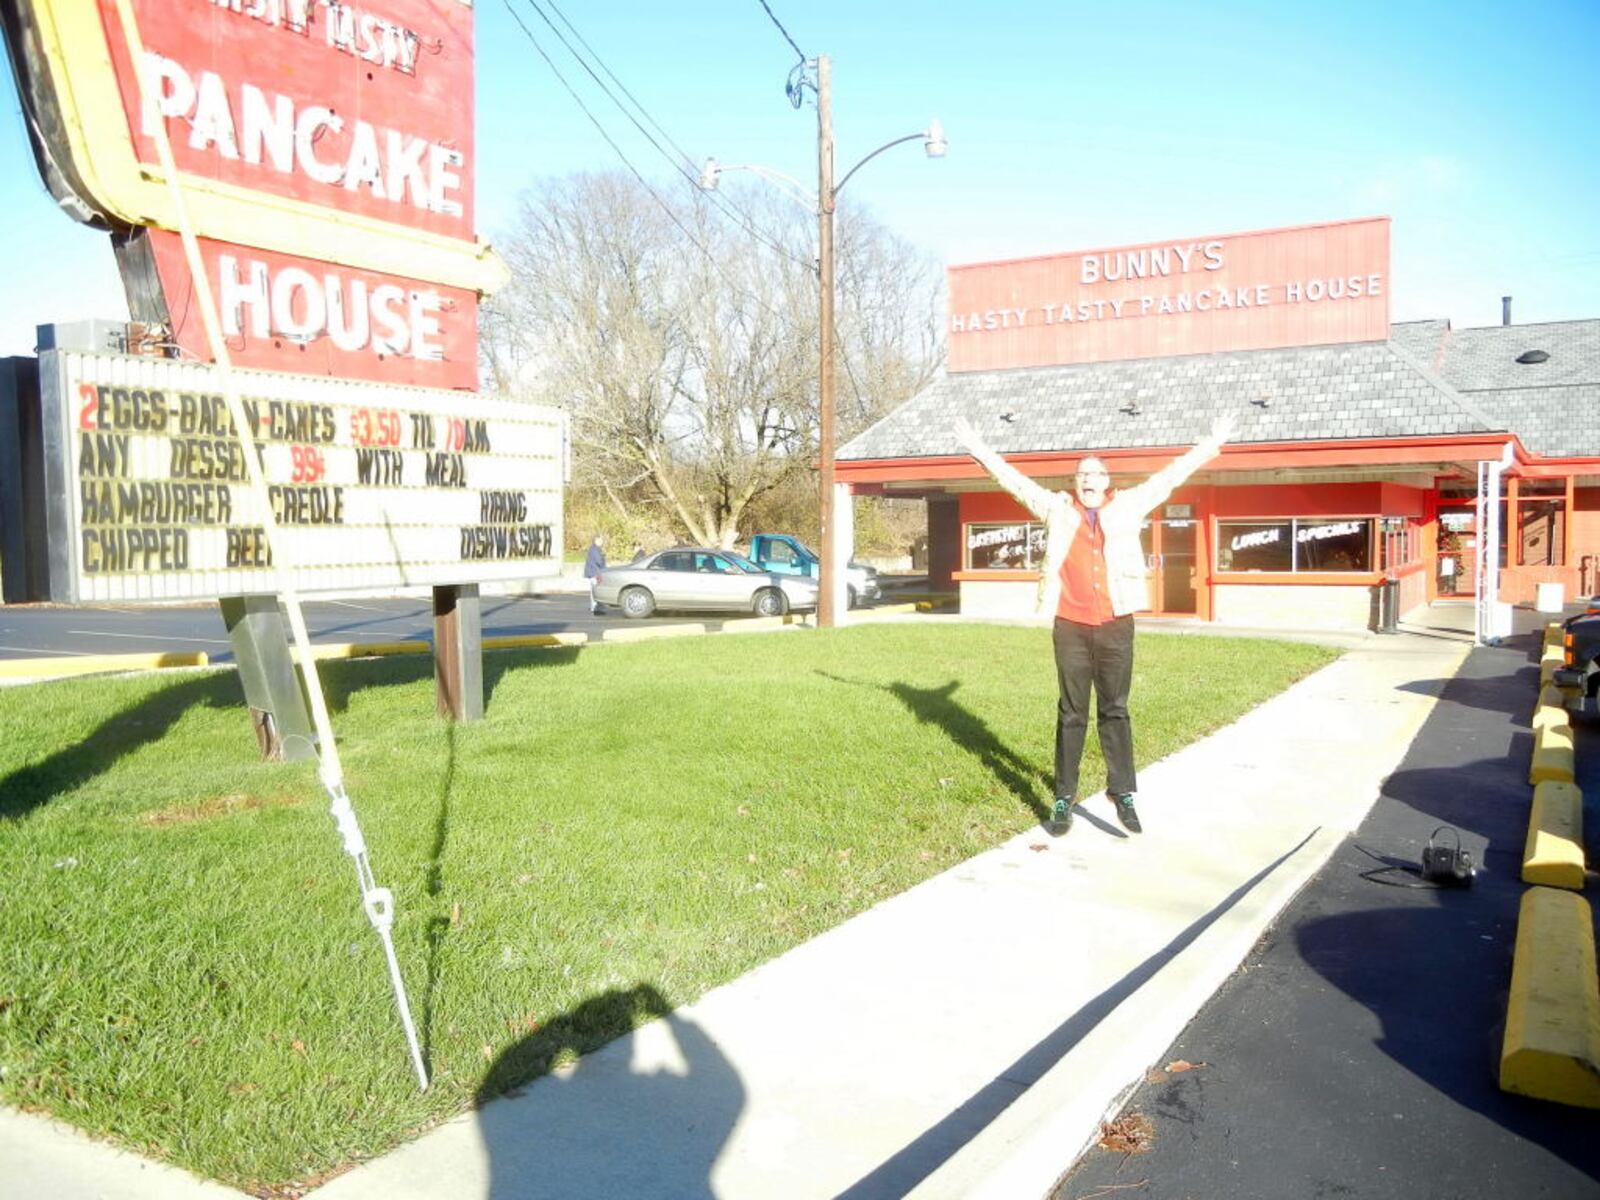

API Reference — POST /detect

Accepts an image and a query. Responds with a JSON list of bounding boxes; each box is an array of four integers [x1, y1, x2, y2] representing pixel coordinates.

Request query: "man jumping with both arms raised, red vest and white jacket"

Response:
[[955, 416, 1234, 837]]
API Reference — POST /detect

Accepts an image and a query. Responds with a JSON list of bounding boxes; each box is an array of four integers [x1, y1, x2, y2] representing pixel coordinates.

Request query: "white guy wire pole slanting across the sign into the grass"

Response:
[[117, 0, 427, 1091]]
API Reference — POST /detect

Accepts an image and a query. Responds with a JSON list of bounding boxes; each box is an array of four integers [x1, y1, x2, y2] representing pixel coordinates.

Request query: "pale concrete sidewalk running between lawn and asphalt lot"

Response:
[[0, 610, 1470, 1200]]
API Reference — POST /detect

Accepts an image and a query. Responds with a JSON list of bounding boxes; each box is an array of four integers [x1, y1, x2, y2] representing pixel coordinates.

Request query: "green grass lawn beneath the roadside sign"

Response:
[[0, 624, 1333, 1192]]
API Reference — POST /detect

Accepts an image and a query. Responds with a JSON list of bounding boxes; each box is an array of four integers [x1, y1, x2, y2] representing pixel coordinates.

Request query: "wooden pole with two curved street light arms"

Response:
[[699, 54, 949, 629]]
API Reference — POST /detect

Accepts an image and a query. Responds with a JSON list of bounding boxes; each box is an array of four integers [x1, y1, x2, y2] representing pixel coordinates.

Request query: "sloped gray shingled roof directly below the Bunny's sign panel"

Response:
[[838, 342, 1507, 459]]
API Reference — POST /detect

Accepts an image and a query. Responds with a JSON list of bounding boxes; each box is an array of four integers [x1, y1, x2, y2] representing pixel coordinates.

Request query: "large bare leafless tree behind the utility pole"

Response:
[[482, 174, 938, 546]]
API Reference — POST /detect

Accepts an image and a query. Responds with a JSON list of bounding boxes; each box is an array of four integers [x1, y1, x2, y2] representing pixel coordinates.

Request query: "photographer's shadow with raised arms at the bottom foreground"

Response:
[[477, 984, 746, 1200]]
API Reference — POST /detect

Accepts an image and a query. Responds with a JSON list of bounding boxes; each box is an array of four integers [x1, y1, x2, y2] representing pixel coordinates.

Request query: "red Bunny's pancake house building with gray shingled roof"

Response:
[[837, 219, 1600, 629]]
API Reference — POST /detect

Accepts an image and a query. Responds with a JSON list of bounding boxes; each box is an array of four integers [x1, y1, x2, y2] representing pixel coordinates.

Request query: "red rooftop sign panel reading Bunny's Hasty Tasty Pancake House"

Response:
[[946, 218, 1389, 371]]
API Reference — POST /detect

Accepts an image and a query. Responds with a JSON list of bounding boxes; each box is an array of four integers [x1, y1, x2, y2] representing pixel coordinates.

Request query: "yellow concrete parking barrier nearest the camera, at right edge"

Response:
[[1501, 888, 1600, 1109]]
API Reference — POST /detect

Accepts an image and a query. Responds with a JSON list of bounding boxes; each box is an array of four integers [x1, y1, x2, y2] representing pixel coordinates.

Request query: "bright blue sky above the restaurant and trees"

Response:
[[0, 0, 1600, 354]]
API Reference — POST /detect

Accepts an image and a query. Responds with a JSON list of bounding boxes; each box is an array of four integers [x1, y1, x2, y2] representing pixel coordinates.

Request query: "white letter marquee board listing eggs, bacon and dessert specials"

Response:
[[40, 350, 566, 603]]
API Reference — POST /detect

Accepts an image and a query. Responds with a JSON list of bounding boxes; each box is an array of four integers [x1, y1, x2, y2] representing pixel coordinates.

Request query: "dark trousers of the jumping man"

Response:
[[1053, 616, 1139, 798]]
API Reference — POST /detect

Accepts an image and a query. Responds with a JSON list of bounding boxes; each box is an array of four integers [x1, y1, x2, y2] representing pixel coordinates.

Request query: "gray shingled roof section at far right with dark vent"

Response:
[[1389, 320, 1600, 458]]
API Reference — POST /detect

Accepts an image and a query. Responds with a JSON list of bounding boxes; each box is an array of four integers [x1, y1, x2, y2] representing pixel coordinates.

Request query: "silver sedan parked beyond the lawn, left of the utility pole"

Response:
[[595, 546, 816, 618]]
